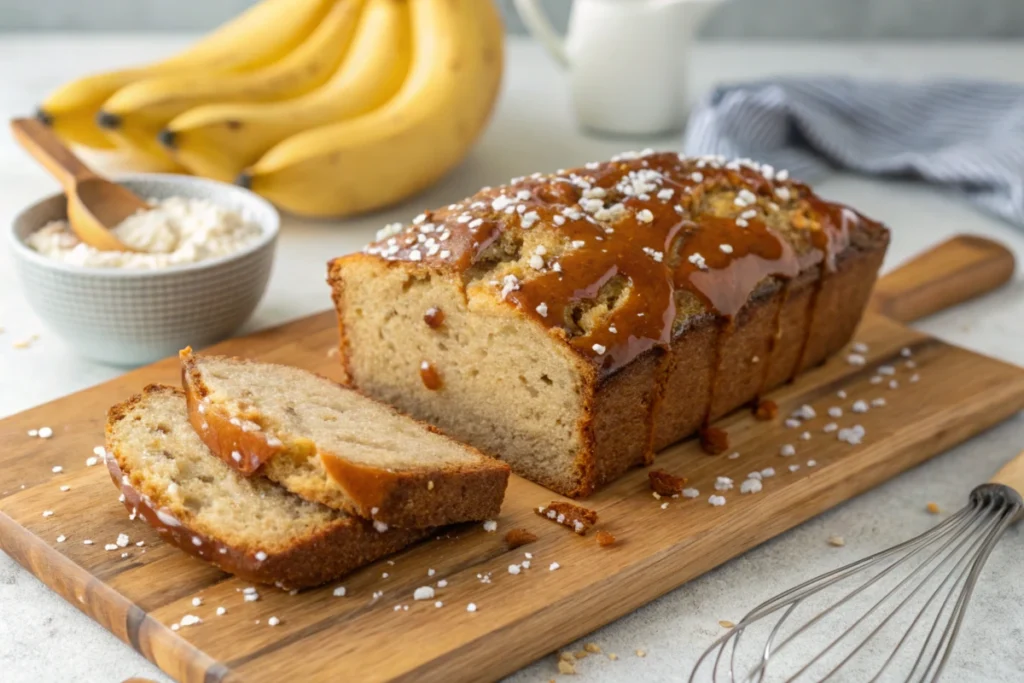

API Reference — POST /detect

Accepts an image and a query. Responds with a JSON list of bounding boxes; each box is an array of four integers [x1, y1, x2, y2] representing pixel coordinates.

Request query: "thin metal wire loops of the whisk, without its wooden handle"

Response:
[[689, 484, 1024, 683]]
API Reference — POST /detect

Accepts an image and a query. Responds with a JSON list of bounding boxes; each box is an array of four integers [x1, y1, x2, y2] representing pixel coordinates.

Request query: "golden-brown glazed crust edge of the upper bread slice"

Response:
[[179, 348, 511, 528]]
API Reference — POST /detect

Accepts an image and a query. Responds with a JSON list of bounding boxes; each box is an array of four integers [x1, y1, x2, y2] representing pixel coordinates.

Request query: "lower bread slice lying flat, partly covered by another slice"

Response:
[[106, 385, 429, 589]]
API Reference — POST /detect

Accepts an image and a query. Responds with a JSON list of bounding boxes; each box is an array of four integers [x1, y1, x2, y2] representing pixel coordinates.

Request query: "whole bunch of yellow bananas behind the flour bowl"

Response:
[[40, 0, 504, 216]]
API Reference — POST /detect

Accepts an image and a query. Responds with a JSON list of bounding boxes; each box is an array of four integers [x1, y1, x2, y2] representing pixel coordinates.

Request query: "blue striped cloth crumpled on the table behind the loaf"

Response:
[[683, 78, 1024, 227]]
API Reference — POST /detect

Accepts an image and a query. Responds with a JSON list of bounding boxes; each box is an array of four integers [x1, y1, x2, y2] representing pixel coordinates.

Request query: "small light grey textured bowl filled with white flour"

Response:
[[9, 174, 280, 366]]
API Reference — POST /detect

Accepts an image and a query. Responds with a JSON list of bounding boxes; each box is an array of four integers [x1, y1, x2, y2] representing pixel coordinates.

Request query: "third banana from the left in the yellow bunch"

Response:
[[161, 0, 412, 182]]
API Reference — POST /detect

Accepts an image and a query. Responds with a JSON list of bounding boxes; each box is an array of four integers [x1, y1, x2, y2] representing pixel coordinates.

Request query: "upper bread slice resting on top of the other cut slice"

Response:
[[180, 349, 509, 528]]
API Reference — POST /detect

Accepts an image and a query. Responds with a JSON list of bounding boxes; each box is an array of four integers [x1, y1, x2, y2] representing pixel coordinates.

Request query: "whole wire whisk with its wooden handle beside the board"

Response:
[[689, 453, 1024, 683]]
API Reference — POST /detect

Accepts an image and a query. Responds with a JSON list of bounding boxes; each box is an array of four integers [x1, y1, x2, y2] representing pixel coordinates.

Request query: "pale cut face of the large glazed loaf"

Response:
[[330, 255, 594, 495]]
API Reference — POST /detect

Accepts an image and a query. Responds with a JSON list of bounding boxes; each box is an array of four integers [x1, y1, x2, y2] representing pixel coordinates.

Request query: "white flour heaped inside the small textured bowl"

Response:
[[26, 197, 261, 269]]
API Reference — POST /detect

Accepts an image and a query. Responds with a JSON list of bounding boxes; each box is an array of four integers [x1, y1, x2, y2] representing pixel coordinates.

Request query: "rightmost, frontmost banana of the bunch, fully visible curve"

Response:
[[239, 0, 503, 216]]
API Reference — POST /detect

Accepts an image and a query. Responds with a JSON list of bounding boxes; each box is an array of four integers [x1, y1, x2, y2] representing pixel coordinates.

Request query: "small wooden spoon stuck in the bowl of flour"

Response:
[[10, 119, 152, 251]]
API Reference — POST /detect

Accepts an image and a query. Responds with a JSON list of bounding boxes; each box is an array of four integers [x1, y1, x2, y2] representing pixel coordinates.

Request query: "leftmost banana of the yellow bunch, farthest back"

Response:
[[37, 0, 334, 150]]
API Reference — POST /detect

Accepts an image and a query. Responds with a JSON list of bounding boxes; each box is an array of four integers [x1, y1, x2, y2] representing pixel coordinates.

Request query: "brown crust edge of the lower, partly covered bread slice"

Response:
[[105, 385, 423, 589]]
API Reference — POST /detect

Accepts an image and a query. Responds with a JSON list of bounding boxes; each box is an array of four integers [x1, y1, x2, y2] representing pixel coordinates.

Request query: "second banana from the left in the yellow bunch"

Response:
[[98, 0, 362, 167]]
